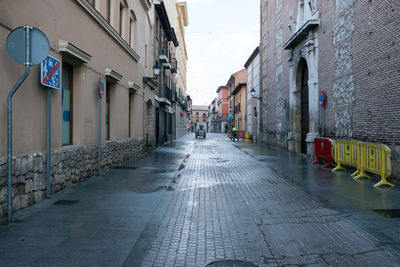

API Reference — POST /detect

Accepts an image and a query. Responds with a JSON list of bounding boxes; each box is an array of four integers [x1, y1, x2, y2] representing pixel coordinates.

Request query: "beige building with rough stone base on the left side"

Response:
[[0, 0, 189, 220]]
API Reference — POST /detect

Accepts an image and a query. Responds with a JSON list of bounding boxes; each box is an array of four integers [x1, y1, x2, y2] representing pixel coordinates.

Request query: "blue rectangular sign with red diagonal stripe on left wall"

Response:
[[40, 56, 61, 90]]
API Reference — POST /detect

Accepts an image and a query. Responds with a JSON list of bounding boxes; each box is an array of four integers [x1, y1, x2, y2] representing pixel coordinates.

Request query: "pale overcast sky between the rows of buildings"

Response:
[[186, 0, 260, 105]]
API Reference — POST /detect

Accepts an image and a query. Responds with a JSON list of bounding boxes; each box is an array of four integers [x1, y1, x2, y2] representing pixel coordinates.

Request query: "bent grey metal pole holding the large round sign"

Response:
[[7, 26, 32, 222]]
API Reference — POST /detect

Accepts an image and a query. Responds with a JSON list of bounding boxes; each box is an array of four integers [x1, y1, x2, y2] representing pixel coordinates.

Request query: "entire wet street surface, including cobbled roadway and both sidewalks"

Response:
[[0, 134, 400, 266]]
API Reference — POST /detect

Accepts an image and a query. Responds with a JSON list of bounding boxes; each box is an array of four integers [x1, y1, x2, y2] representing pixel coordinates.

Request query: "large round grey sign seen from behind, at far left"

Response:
[[7, 26, 50, 65]]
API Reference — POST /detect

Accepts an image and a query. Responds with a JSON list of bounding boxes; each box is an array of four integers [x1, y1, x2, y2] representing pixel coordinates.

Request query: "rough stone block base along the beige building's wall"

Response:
[[0, 138, 144, 218]]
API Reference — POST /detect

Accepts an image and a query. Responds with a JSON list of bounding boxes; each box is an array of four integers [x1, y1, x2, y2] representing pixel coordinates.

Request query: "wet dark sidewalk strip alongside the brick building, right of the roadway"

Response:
[[235, 142, 400, 252]]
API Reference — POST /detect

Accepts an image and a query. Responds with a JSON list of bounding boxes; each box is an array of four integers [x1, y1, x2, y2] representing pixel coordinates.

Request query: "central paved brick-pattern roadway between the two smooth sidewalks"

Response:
[[142, 135, 400, 266]]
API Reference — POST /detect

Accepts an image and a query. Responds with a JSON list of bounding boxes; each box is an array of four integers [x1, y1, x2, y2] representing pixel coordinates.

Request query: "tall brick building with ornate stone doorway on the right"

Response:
[[260, 0, 400, 180]]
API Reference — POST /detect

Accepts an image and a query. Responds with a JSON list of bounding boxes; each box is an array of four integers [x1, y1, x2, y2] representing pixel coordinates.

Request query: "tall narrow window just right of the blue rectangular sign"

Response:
[[61, 62, 72, 145]]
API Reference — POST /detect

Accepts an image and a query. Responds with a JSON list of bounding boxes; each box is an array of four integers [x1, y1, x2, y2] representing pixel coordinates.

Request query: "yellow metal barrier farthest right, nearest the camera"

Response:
[[354, 143, 394, 187]]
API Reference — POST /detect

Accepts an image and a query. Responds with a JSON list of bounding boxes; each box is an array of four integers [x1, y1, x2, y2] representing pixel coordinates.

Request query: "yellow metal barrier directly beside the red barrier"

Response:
[[332, 140, 360, 176]]
